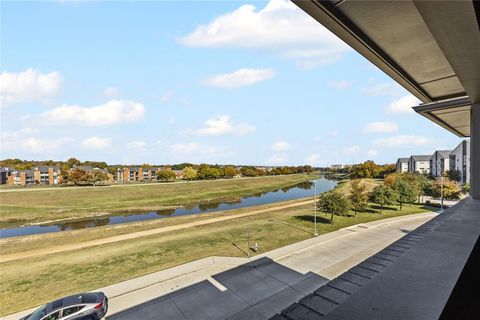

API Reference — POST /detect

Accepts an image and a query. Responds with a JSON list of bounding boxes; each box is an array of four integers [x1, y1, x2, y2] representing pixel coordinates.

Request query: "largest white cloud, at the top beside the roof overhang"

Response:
[[178, 0, 350, 68]]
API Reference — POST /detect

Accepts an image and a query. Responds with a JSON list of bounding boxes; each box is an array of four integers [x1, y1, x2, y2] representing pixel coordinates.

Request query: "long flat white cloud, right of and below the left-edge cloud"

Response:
[[41, 100, 145, 126]]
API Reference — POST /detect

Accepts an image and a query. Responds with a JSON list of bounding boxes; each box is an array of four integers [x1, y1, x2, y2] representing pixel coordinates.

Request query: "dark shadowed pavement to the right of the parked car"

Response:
[[107, 258, 328, 320]]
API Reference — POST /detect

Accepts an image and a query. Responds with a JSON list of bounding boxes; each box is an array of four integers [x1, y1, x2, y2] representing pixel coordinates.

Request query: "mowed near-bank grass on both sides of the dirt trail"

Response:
[[0, 199, 436, 315]]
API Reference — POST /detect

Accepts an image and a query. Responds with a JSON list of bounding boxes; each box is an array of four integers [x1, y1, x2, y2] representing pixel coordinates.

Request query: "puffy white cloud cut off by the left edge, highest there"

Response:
[[0, 68, 61, 106]]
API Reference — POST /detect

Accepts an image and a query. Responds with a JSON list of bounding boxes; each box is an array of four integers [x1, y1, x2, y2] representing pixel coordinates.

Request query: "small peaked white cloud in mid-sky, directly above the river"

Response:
[[197, 115, 255, 136]]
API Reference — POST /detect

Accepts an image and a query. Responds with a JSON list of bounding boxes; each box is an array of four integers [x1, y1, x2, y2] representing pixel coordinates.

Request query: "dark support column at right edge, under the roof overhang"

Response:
[[470, 103, 480, 200]]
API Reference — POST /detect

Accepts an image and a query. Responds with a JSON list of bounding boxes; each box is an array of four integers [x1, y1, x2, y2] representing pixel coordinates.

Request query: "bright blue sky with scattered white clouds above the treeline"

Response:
[[0, 0, 460, 166]]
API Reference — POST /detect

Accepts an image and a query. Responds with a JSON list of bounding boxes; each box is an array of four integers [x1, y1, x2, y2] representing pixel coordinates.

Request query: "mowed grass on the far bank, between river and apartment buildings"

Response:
[[0, 174, 313, 227]]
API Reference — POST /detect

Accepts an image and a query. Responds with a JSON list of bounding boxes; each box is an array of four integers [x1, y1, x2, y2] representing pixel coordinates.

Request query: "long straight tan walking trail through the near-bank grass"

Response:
[[0, 200, 313, 262]]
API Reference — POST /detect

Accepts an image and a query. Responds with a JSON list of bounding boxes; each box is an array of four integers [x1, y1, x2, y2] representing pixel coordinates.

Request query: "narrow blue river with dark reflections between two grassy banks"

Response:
[[0, 178, 337, 238]]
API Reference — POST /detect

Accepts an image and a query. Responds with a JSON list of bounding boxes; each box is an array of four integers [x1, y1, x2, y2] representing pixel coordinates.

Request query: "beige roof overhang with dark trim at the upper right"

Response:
[[293, 0, 480, 136]]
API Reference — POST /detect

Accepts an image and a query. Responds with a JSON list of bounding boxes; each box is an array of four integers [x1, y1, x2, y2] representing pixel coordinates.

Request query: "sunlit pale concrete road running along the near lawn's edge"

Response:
[[0, 213, 436, 320]]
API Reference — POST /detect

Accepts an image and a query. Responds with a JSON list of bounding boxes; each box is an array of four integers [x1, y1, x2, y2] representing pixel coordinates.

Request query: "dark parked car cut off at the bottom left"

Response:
[[20, 292, 108, 320]]
